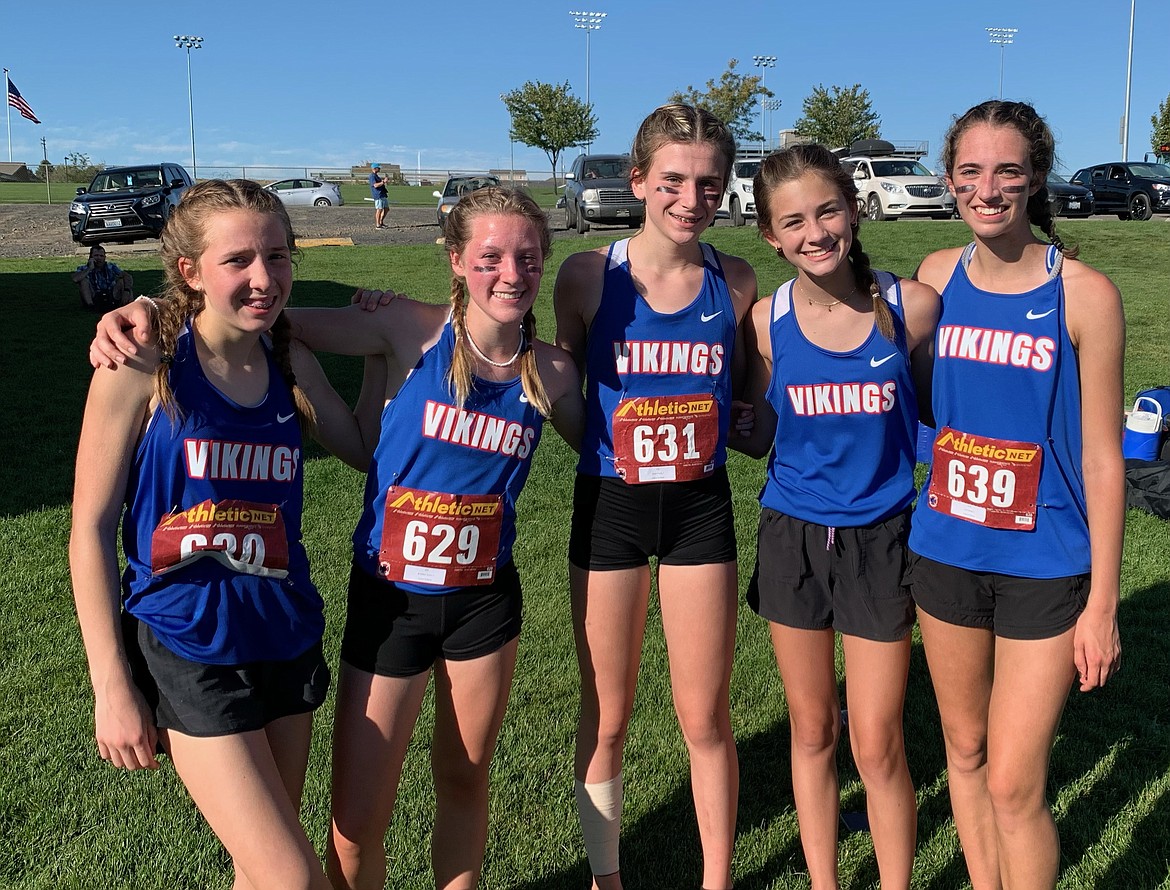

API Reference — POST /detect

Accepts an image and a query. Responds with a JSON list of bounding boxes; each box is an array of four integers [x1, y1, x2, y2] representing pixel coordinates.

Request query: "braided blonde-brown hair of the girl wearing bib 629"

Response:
[[445, 187, 552, 418]]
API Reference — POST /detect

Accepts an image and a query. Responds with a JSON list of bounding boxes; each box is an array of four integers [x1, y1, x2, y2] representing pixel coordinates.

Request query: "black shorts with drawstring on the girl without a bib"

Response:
[[748, 506, 914, 642]]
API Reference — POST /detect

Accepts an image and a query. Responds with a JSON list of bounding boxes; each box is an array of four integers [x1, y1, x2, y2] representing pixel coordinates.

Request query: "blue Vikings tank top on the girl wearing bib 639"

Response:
[[910, 244, 1089, 578]]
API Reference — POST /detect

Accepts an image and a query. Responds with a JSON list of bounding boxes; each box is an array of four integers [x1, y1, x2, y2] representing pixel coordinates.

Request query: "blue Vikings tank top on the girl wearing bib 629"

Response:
[[353, 319, 544, 594]]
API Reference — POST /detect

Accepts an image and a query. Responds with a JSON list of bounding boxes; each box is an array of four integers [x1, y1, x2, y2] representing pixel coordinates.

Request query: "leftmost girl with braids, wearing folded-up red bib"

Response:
[[70, 180, 371, 890]]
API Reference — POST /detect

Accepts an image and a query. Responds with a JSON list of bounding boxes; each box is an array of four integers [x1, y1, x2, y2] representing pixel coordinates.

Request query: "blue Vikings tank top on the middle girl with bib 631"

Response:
[[577, 239, 736, 478]]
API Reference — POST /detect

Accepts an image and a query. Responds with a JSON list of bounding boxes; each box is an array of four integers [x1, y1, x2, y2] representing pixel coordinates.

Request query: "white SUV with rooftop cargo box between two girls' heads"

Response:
[[841, 157, 955, 220]]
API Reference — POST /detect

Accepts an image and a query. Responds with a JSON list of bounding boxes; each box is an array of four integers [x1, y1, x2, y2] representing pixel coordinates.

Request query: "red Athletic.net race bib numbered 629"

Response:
[[378, 485, 504, 587]]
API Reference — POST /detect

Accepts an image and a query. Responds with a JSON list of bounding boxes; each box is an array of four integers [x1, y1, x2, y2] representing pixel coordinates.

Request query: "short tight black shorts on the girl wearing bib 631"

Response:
[[569, 467, 736, 571]]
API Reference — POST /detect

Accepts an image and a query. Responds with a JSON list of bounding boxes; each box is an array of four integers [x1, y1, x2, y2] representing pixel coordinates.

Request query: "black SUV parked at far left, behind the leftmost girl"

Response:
[[69, 164, 194, 244]]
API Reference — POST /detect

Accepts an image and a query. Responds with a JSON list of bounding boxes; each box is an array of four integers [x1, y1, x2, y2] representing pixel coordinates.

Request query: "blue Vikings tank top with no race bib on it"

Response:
[[759, 271, 918, 527]]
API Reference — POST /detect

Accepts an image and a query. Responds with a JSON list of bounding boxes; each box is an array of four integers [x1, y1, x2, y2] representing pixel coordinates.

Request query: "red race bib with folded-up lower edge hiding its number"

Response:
[[150, 501, 289, 578]]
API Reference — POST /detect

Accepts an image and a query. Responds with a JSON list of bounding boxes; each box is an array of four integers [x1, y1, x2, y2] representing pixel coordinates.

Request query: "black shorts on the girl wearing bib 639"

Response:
[[906, 553, 1089, 640]]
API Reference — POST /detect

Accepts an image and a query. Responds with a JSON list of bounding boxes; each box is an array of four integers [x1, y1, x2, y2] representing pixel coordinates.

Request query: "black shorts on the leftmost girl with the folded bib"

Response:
[[122, 612, 329, 737]]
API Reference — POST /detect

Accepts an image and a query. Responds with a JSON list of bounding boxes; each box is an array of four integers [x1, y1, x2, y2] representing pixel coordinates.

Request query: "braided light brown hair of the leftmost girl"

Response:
[[154, 179, 316, 433]]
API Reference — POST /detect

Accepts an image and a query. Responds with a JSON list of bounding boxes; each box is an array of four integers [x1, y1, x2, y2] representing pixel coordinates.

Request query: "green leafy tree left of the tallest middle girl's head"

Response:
[[500, 81, 597, 189]]
